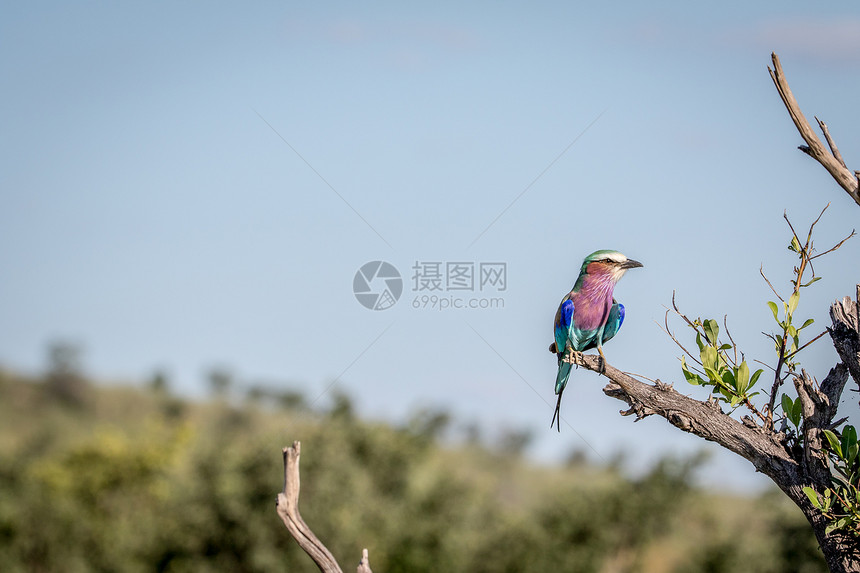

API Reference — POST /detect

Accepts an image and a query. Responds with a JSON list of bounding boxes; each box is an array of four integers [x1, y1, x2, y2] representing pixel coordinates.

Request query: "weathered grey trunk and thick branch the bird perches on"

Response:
[[576, 285, 860, 573]]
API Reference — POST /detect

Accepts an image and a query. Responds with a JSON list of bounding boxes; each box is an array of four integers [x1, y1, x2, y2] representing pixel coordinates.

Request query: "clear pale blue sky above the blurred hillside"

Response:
[[0, 2, 860, 484]]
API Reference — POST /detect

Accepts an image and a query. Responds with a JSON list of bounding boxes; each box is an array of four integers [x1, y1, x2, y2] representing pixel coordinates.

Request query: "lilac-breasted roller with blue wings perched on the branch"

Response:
[[549, 251, 642, 432]]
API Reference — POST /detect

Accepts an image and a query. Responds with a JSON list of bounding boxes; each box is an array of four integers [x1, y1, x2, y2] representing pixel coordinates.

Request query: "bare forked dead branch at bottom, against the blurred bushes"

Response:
[[275, 441, 373, 573]]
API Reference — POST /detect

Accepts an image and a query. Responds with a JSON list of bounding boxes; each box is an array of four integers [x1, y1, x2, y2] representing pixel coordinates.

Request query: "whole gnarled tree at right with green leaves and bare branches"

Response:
[[564, 54, 860, 573]]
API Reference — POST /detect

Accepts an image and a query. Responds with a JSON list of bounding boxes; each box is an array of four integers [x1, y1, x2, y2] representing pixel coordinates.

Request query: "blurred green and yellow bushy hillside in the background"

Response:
[[0, 362, 825, 573]]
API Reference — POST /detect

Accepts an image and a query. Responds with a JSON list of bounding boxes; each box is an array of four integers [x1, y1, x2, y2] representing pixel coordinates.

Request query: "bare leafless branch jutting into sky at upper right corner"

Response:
[[767, 53, 860, 205]]
